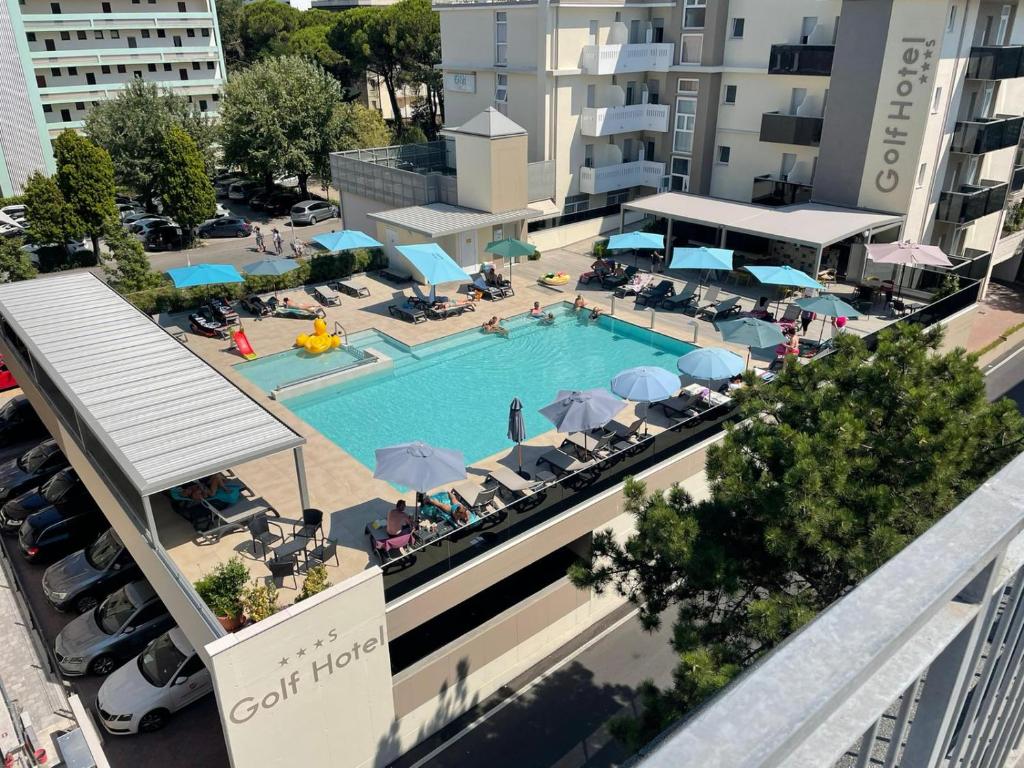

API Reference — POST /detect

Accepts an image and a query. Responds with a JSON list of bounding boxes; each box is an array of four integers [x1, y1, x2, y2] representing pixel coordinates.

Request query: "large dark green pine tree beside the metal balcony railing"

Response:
[[570, 326, 1024, 748]]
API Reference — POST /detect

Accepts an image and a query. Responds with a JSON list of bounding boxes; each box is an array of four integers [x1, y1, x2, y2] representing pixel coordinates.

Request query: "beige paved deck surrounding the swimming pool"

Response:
[[154, 241, 905, 604]]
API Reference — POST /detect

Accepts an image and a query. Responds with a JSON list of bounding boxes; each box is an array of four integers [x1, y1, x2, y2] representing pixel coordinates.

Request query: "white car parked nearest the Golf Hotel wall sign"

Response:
[[96, 628, 213, 735]]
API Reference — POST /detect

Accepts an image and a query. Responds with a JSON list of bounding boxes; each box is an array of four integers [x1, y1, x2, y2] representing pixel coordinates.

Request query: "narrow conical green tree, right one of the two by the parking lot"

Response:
[[160, 125, 217, 243]]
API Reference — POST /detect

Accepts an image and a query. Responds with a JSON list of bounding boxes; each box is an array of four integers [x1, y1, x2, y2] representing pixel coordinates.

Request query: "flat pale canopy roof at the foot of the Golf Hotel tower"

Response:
[[623, 193, 903, 248]]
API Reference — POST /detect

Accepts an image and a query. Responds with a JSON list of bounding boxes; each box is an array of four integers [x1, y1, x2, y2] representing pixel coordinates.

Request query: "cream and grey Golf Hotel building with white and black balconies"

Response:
[[434, 0, 1024, 276]]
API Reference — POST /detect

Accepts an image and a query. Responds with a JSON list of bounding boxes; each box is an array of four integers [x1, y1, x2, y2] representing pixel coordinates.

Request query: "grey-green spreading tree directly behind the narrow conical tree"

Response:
[[85, 80, 216, 210]]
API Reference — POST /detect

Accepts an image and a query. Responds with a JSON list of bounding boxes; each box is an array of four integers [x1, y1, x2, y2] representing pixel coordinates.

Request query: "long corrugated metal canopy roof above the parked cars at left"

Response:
[[0, 273, 305, 496]]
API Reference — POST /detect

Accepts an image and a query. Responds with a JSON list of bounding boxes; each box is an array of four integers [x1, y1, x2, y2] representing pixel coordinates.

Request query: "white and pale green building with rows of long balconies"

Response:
[[0, 0, 225, 196]]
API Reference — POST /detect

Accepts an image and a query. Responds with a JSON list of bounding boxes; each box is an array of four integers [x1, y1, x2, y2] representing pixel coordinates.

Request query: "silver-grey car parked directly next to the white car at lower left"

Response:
[[53, 580, 174, 676]]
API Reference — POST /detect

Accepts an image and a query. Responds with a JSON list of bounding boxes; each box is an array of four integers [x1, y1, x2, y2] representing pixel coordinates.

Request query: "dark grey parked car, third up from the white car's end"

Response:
[[43, 528, 140, 613]]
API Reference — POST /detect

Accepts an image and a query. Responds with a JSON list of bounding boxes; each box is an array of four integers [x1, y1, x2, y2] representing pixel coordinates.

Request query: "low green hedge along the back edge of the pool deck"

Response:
[[125, 248, 386, 314]]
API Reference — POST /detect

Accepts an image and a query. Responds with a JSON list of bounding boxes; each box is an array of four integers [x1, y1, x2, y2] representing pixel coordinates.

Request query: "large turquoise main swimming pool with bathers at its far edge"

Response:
[[239, 303, 694, 468]]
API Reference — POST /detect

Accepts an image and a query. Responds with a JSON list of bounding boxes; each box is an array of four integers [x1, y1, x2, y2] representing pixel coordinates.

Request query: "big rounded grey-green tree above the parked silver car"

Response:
[[220, 56, 342, 195]]
